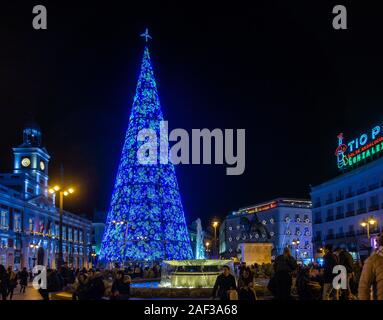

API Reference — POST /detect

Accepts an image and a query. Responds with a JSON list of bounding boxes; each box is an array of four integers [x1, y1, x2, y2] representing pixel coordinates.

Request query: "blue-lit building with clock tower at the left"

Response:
[[0, 123, 91, 269]]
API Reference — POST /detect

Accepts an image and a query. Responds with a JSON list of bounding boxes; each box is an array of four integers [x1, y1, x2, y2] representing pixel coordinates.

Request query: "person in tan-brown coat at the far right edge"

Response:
[[358, 234, 383, 300]]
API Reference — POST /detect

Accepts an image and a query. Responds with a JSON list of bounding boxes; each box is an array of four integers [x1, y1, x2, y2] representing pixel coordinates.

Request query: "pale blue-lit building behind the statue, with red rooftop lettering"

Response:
[[219, 198, 313, 262]]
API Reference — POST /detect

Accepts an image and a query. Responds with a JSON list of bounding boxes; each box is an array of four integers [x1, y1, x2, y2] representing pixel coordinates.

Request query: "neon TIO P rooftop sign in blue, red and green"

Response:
[[335, 126, 383, 170]]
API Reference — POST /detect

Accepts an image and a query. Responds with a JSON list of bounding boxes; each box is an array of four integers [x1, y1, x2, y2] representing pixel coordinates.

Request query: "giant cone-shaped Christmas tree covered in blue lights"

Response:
[[100, 47, 193, 262]]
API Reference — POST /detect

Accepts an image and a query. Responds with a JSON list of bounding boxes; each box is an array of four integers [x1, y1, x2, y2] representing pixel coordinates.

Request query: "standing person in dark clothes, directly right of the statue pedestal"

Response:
[[274, 248, 297, 300]]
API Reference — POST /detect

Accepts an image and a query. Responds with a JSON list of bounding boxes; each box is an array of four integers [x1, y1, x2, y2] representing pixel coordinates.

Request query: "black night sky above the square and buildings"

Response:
[[0, 0, 383, 223]]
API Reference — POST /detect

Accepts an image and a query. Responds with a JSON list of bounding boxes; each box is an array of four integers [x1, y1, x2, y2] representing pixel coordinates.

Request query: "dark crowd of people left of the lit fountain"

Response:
[[0, 264, 161, 300]]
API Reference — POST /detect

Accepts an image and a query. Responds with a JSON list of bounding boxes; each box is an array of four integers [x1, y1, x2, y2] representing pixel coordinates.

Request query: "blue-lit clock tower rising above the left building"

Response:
[[13, 122, 50, 197]]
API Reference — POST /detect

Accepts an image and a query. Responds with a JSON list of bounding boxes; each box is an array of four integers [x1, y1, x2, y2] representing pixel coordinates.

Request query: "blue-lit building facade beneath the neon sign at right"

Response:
[[311, 158, 383, 259]]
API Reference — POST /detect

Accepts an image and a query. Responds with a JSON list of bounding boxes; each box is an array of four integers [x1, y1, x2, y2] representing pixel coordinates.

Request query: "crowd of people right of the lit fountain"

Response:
[[213, 235, 383, 300]]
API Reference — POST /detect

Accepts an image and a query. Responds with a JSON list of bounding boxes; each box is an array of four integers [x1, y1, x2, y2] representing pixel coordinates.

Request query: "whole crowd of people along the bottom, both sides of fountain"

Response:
[[0, 235, 383, 301]]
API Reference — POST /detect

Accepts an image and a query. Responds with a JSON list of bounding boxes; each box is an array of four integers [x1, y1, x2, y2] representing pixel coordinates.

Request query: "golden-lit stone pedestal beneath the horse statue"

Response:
[[240, 243, 273, 265]]
